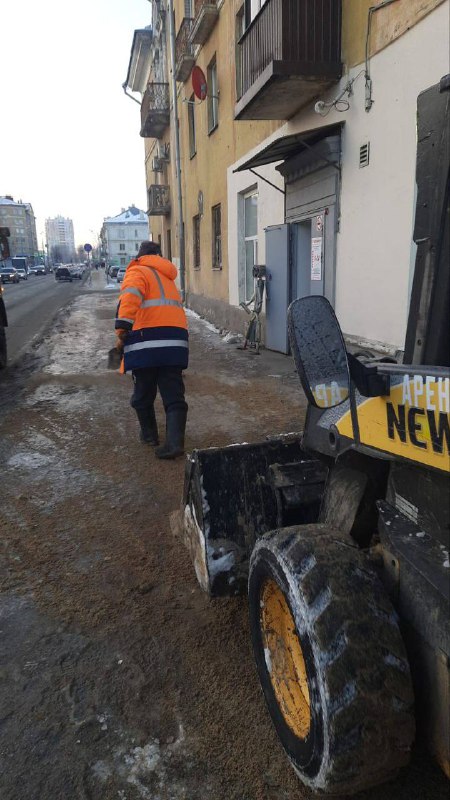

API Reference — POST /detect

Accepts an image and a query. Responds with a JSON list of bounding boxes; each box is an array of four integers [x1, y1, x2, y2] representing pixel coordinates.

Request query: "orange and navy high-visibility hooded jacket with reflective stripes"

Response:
[[115, 256, 189, 372]]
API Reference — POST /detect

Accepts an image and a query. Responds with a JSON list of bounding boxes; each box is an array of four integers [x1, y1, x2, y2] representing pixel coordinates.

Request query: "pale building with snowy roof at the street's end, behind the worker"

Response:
[[101, 206, 149, 266]]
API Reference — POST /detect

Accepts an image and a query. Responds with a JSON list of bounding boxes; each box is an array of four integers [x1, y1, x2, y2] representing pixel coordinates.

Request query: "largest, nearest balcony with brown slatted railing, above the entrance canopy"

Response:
[[234, 0, 342, 120]]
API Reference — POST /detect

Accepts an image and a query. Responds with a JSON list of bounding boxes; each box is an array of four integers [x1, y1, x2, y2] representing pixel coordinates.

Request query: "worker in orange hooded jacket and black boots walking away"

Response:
[[115, 242, 189, 459]]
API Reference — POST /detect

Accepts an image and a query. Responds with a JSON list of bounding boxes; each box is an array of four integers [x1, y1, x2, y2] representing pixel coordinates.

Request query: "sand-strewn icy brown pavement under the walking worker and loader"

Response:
[[0, 284, 446, 800]]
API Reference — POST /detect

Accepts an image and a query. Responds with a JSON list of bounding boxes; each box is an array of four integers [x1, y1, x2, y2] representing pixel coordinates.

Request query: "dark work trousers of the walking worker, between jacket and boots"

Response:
[[131, 367, 188, 413]]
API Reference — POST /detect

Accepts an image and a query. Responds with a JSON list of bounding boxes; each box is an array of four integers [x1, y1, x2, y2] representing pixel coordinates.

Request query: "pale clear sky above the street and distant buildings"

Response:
[[0, 0, 151, 244]]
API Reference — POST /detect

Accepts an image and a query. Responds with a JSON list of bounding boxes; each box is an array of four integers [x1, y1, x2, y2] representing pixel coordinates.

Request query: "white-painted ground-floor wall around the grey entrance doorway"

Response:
[[228, 2, 449, 349]]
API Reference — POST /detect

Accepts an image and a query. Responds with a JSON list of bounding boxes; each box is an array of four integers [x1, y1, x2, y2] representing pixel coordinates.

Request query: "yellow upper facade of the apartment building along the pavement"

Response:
[[127, 0, 448, 339]]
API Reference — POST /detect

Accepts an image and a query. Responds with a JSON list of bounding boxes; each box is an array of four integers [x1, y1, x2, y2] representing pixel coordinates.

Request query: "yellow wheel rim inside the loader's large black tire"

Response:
[[260, 580, 311, 739]]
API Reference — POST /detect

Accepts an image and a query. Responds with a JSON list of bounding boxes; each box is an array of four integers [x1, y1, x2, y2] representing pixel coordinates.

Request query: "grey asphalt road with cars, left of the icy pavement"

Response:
[[3, 274, 84, 366]]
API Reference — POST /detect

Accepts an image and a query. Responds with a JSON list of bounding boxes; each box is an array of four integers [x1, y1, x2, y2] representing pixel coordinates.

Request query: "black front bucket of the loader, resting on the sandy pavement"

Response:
[[182, 434, 327, 596]]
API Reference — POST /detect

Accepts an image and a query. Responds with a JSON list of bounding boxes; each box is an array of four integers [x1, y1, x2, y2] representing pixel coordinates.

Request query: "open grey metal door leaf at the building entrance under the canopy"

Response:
[[266, 224, 291, 353]]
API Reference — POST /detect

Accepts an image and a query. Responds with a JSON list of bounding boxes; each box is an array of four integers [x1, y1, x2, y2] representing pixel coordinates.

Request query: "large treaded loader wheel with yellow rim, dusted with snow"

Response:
[[249, 525, 415, 794]]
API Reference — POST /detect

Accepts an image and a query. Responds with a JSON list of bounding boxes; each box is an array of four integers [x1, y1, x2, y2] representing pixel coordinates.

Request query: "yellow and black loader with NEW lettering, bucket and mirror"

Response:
[[178, 78, 450, 795]]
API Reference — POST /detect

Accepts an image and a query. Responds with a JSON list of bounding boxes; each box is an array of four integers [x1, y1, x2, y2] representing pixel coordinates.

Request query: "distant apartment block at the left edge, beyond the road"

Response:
[[0, 195, 39, 264]]
